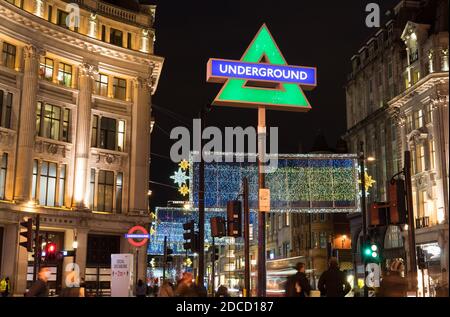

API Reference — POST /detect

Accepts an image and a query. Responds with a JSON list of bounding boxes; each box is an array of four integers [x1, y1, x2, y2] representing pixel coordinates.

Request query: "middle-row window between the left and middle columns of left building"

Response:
[[36, 102, 70, 142]]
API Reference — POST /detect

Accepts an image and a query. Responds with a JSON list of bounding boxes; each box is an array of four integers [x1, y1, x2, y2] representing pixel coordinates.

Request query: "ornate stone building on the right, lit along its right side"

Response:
[[345, 0, 449, 296]]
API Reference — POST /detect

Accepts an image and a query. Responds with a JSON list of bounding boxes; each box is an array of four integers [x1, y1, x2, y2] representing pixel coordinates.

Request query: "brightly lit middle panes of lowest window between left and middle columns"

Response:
[[39, 161, 58, 207]]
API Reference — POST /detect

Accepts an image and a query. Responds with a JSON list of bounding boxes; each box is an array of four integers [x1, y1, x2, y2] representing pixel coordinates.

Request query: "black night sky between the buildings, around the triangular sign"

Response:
[[150, 0, 397, 208]]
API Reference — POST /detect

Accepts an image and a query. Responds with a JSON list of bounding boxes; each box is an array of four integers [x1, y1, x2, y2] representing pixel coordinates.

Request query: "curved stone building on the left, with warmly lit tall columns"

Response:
[[0, 0, 164, 294]]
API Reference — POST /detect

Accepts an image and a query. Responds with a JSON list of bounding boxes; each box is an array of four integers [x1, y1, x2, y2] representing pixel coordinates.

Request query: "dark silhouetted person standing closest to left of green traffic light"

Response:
[[318, 258, 352, 297]]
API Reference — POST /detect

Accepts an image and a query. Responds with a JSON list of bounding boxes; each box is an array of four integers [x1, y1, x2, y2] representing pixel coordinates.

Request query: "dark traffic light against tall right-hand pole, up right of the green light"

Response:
[[389, 179, 407, 225]]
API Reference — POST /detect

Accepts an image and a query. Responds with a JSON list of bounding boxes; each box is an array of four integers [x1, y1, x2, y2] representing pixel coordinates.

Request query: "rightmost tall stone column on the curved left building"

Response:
[[129, 78, 151, 212]]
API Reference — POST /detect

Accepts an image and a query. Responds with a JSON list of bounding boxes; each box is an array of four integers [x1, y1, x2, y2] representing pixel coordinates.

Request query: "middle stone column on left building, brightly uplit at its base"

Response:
[[73, 63, 98, 209]]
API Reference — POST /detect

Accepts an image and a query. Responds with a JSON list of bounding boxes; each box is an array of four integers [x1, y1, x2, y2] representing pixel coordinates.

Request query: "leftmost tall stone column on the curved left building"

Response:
[[14, 45, 40, 202]]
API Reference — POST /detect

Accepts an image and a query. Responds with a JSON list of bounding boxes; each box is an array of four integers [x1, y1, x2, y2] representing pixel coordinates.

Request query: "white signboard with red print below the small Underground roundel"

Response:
[[111, 254, 133, 297]]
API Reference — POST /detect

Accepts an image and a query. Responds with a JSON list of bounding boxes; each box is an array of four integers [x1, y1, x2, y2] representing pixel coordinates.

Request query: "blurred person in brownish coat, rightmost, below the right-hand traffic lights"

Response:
[[377, 260, 408, 297]]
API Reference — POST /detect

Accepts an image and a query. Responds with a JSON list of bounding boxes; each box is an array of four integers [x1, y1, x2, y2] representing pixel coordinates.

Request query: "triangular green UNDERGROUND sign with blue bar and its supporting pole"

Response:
[[206, 24, 317, 297]]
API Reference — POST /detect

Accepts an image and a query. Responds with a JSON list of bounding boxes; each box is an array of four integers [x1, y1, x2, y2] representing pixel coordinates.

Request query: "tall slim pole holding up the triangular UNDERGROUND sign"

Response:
[[258, 106, 266, 297]]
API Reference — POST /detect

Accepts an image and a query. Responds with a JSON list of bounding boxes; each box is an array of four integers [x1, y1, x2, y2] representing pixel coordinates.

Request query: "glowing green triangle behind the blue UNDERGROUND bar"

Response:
[[213, 24, 311, 111]]
